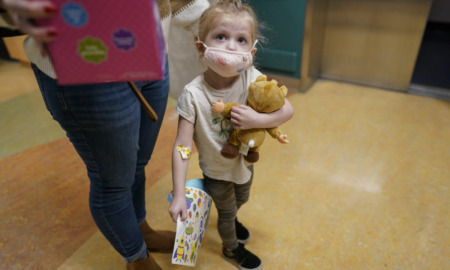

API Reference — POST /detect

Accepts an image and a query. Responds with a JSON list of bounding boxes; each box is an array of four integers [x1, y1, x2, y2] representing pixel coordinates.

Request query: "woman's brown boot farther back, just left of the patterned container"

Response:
[[139, 221, 175, 253]]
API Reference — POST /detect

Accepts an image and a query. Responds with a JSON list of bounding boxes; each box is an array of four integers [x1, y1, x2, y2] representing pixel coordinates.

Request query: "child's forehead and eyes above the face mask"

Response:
[[204, 13, 253, 52]]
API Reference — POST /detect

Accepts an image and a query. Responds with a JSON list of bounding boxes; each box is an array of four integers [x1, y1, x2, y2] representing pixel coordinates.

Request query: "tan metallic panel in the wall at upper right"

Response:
[[321, 0, 431, 91]]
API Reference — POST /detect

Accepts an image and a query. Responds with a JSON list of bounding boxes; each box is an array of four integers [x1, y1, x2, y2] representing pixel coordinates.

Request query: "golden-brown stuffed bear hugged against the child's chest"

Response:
[[212, 74, 289, 163]]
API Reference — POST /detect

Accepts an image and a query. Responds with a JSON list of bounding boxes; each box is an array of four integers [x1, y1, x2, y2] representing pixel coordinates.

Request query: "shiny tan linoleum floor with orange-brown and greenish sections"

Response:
[[0, 60, 450, 270]]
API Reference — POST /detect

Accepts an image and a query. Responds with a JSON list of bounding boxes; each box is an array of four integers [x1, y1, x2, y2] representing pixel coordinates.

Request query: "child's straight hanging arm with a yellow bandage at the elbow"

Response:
[[169, 116, 194, 222]]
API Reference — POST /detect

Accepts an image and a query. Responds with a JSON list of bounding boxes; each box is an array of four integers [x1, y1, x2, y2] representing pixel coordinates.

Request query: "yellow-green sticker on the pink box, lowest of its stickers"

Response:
[[78, 37, 108, 64]]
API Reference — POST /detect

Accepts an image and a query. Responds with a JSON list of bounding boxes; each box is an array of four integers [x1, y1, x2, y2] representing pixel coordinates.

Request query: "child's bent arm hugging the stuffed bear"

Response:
[[231, 99, 294, 129]]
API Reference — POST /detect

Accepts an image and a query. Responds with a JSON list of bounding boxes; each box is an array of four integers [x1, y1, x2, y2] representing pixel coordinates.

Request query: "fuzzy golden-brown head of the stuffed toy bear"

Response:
[[248, 75, 287, 113]]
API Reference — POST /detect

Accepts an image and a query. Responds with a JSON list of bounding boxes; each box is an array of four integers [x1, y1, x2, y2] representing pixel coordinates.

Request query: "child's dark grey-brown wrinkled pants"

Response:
[[203, 166, 253, 249]]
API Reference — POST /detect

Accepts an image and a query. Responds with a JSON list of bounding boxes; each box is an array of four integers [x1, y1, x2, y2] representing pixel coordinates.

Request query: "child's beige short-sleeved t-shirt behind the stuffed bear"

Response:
[[176, 66, 261, 184]]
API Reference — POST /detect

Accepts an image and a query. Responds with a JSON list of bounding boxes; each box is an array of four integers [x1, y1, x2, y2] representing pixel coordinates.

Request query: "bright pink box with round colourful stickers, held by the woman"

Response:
[[36, 0, 166, 85]]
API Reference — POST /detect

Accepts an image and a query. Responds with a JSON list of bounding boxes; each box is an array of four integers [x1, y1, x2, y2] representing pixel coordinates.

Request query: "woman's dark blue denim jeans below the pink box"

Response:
[[32, 62, 169, 262]]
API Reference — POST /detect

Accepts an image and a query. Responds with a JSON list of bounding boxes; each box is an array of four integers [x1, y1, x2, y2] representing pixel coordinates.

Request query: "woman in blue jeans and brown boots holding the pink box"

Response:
[[0, 0, 209, 269]]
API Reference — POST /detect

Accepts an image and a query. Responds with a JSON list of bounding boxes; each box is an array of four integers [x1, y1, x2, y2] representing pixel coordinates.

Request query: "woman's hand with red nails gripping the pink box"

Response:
[[0, 0, 58, 42]]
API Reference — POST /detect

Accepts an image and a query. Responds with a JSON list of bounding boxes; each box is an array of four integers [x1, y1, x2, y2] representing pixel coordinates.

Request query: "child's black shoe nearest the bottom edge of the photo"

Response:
[[222, 243, 262, 270]]
